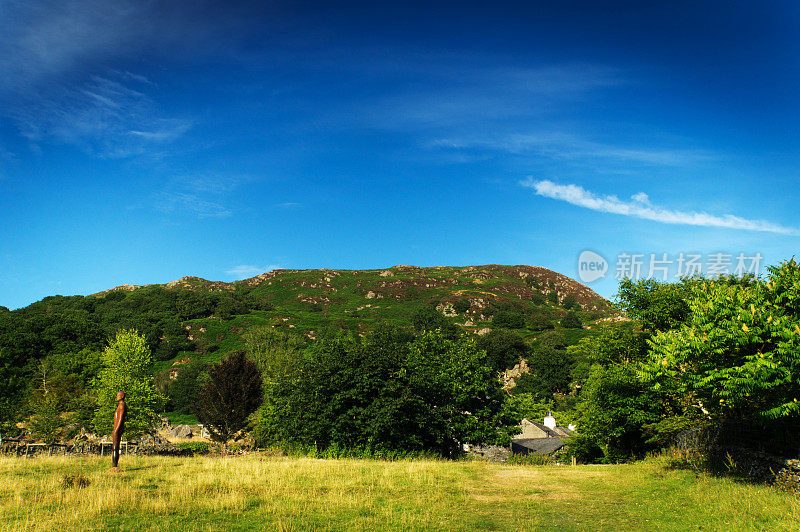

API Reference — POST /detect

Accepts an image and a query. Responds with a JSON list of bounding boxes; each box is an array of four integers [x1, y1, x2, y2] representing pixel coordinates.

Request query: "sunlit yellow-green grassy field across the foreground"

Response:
[[0, 455, 800, 531]]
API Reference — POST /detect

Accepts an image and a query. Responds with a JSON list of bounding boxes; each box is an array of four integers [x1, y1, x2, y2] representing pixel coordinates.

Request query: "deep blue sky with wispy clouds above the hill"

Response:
[[0, 0, 800, 308]]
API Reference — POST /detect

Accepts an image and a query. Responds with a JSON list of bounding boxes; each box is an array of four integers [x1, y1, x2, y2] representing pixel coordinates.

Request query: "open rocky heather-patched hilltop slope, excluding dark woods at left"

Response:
[[95, 265, 611, 352]]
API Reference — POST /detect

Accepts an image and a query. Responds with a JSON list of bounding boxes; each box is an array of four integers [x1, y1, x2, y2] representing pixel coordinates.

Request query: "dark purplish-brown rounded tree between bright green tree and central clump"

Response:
[[195, 350, 263, 444]]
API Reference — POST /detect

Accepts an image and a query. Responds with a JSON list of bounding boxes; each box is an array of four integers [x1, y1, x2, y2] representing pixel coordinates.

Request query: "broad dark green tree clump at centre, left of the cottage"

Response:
[[260, 329, 510, 456]]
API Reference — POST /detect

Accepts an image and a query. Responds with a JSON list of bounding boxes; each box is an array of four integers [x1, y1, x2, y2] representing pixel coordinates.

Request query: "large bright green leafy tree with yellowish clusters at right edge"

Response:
[[640, 259, 800, 419]]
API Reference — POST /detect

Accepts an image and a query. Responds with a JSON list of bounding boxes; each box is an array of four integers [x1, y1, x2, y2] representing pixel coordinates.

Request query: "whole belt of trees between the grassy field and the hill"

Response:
[[7, 259, 800, 462]]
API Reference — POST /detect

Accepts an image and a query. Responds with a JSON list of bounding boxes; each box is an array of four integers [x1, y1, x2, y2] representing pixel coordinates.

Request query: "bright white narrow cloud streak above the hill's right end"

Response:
[[520, 179, 800, 236]]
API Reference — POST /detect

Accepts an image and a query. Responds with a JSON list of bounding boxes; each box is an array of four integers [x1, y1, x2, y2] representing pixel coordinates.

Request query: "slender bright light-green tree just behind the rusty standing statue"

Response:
[[94, 330, 163, 437]]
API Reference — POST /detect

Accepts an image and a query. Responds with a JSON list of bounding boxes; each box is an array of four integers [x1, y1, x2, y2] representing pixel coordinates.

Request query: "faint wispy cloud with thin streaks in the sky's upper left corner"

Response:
[[0, 0, 212, 159]]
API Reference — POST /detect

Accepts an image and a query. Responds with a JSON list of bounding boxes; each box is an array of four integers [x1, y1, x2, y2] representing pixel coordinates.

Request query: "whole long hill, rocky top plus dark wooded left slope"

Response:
[[0, 265, 612, 428]]
